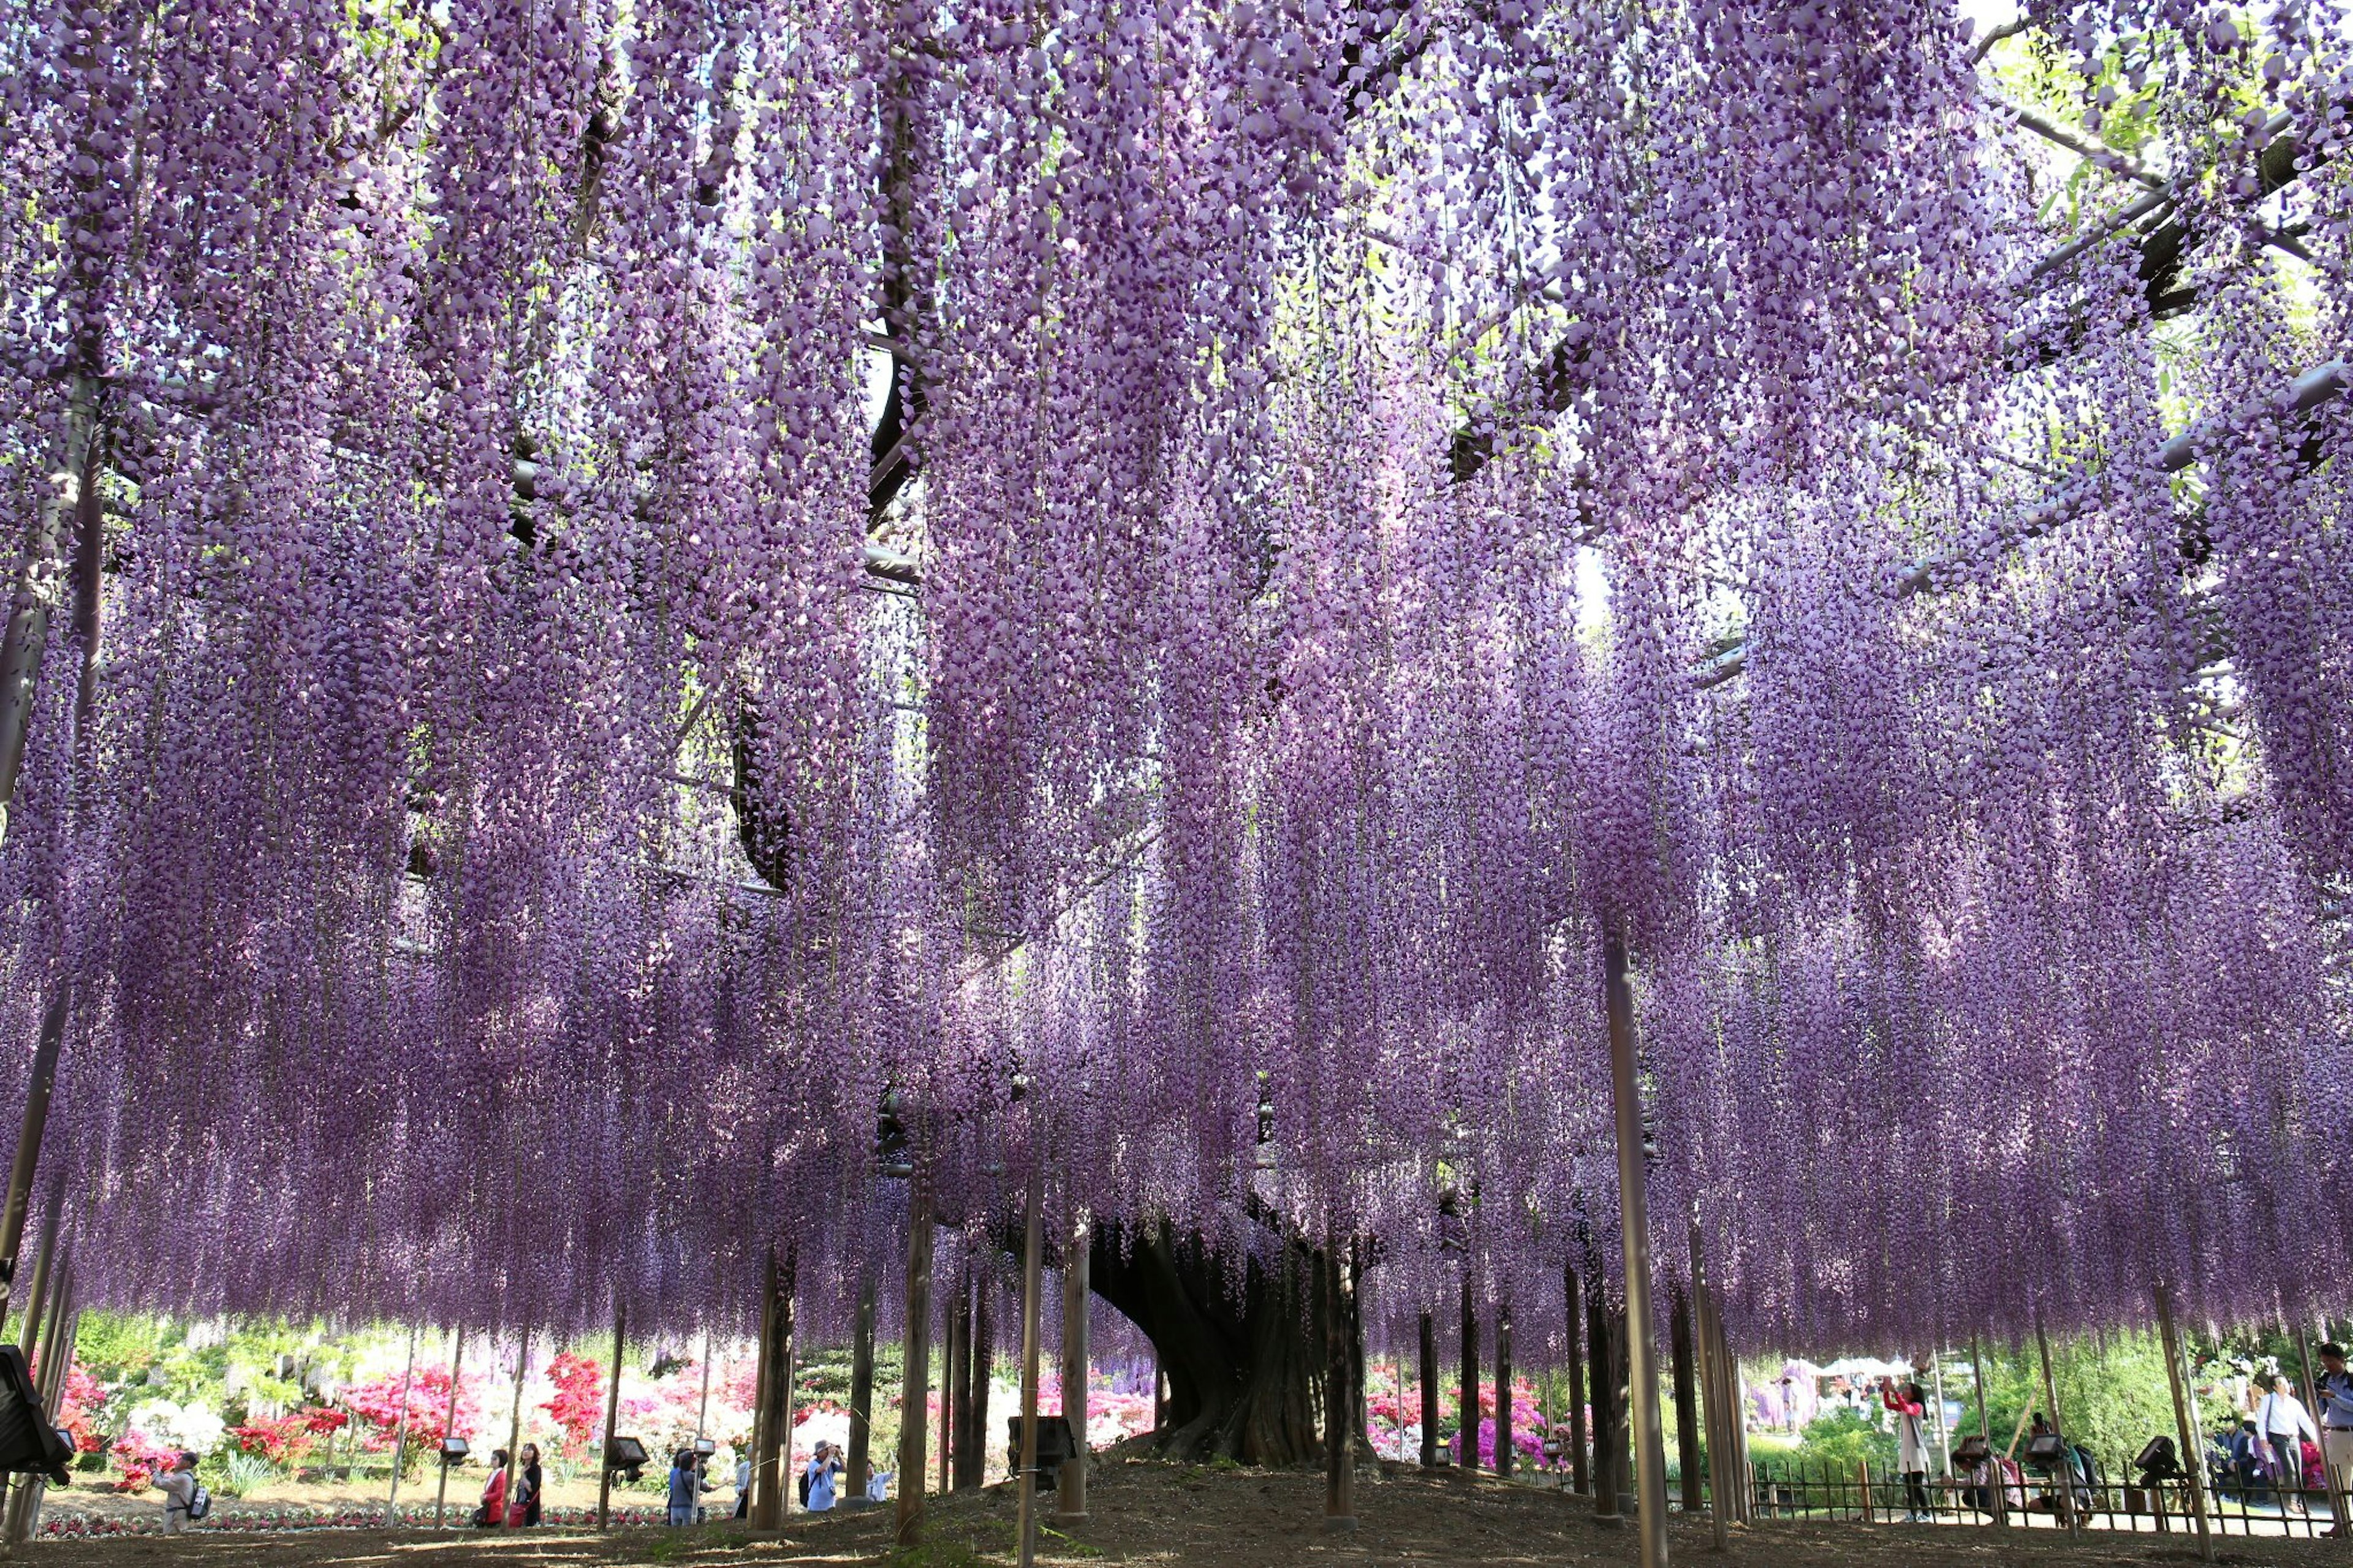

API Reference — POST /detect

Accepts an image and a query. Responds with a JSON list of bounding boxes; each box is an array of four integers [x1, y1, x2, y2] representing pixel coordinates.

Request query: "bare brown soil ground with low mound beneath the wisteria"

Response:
[[28, 1460, 2353, 1568]]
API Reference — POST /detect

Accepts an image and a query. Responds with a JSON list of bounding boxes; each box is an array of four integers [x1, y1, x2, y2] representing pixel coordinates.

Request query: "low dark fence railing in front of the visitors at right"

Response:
[[1753, 1460, 2346, 1537]]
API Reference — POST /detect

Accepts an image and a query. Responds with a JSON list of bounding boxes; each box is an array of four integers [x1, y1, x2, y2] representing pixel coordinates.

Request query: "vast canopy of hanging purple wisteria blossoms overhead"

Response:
[[0, 0, 2353, 1347]]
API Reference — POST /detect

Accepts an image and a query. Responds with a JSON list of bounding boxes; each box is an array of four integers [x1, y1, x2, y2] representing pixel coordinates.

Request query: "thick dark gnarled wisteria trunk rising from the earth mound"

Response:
[[1087, 1224, 1365, 1467]]
